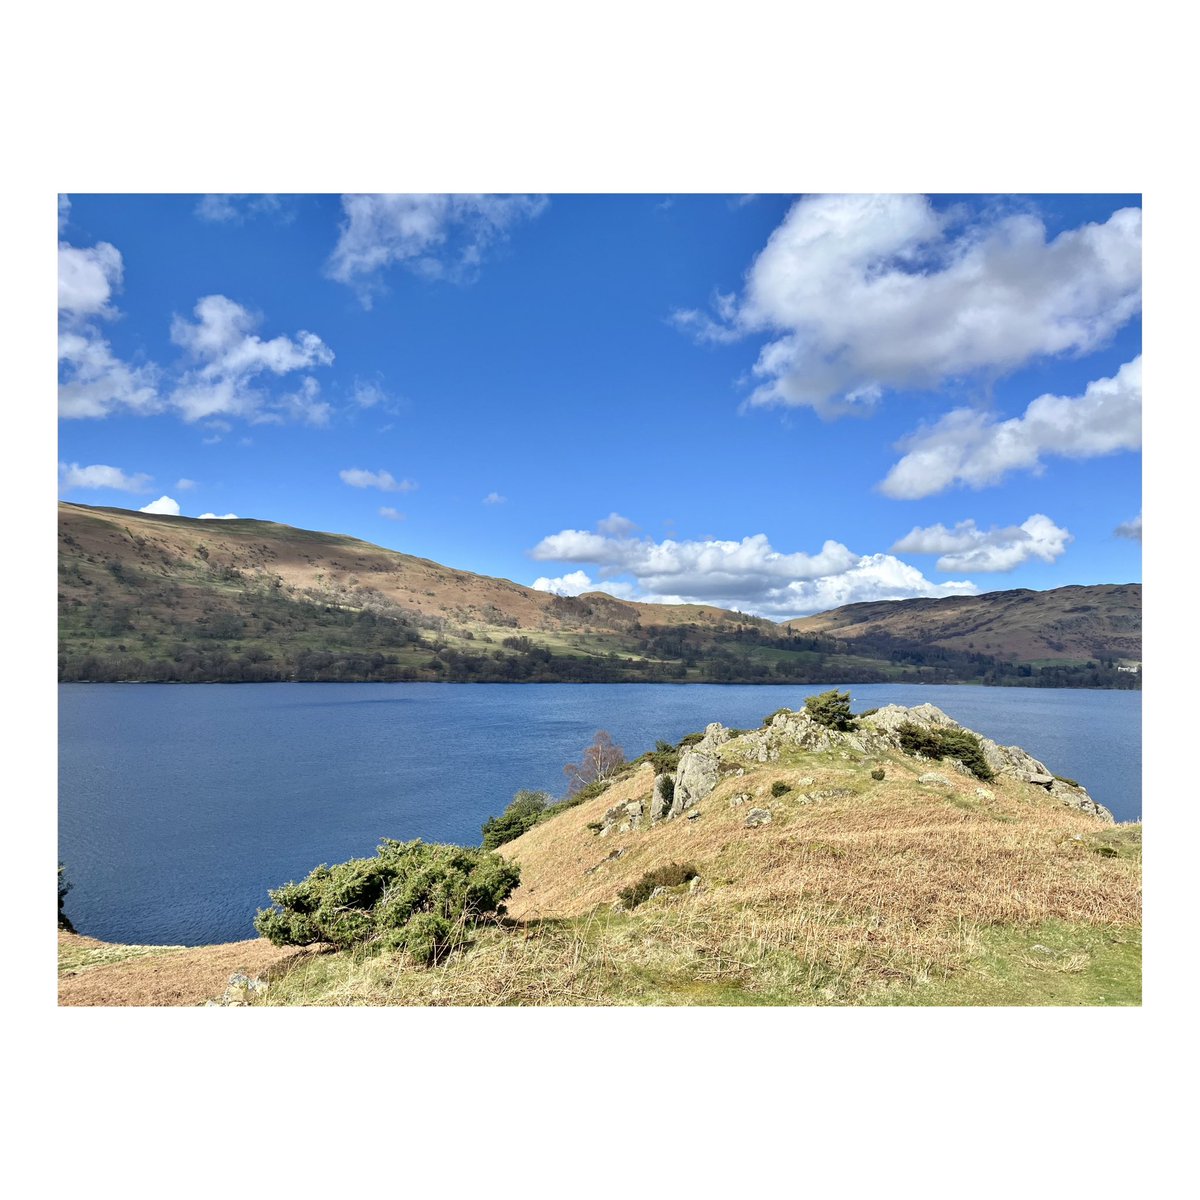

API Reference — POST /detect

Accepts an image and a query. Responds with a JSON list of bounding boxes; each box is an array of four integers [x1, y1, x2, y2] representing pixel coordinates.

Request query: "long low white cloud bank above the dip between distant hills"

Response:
[[530, 518, 977, 616]]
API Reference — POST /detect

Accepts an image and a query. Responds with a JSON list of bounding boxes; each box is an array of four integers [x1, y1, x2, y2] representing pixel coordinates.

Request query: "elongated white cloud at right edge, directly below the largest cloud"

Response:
[[880, 354, 1141, 499]]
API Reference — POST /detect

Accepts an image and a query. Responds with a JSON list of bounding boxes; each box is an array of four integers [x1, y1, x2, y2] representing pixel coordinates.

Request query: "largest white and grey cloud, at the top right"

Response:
[[674, 196, 1141, 416]]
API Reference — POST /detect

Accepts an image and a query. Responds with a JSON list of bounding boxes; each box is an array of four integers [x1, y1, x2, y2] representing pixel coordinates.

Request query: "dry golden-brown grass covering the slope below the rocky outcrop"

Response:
[[502, 755, 1141, 986]]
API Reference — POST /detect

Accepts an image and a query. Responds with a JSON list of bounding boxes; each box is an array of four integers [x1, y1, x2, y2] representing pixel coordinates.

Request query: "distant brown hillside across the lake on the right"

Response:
[[786, 583, 1141, 665]]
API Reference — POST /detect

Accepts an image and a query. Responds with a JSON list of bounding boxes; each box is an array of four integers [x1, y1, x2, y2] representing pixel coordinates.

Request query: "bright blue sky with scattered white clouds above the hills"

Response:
[[59, 196, 1141, 618]]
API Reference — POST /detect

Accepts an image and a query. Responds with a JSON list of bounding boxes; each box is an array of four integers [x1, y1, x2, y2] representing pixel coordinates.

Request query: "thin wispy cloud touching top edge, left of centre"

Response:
[[328, 194, 548, 307]]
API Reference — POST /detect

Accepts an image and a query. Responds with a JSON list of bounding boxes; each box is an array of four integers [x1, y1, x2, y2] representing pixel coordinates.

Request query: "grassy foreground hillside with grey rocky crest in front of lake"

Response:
[[60, 706, 1141, 1004]]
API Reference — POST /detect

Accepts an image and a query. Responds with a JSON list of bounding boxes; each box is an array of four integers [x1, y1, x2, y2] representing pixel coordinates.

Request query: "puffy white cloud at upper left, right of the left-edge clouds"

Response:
[[170, 295, 334, 425]]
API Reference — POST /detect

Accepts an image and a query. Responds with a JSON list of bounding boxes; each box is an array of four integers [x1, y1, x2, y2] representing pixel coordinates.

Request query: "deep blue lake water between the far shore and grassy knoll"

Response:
[[59, 684, 1141, 946]]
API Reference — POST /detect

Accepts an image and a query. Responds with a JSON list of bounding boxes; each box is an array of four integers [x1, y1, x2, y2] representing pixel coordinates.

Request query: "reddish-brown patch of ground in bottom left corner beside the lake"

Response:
[[59, 934, 313, 1007]]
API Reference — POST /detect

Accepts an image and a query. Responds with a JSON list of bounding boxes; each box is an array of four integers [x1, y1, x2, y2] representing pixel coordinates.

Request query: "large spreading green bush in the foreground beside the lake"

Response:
[[254, 838, 521, 964]]
